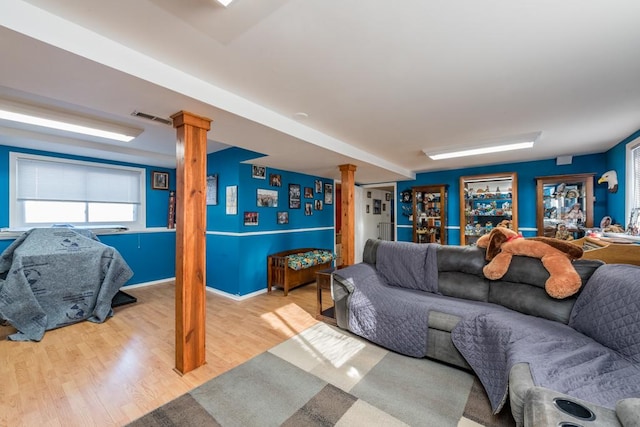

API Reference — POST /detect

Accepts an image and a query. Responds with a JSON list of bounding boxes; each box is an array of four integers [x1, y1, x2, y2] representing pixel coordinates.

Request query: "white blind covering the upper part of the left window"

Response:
[[16, 158, 141, 204]]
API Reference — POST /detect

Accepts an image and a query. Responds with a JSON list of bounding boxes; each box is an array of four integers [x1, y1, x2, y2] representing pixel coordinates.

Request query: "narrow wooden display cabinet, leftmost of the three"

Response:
[[411, 184, 447, 245]]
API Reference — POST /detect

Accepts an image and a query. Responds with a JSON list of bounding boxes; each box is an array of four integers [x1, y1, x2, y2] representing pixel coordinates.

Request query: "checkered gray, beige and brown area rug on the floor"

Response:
[[130, 323, 515, 427]]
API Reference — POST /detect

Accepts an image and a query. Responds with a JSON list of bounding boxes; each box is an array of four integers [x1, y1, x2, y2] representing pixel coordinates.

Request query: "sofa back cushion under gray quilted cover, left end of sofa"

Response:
[[376, 241, 438, 293]]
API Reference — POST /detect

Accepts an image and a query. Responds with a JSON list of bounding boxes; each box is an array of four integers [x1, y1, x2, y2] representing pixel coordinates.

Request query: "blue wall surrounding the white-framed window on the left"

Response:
[[0, 145, 176, 285]]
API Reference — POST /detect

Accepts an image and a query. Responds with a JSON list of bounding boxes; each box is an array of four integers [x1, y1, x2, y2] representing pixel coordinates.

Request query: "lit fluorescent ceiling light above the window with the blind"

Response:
[[0, 99, 142, 142]]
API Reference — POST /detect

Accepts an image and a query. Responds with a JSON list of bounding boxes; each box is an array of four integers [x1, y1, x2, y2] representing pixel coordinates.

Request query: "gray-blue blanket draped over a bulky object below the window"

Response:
[[0, 228, 133, 341]]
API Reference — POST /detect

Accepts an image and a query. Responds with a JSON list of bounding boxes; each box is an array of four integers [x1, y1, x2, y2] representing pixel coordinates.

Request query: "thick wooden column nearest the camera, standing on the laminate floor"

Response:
[[171, 111, 211, 374]]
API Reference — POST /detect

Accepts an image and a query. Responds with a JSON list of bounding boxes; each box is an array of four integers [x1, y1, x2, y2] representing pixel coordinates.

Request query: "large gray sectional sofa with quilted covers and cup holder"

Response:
[[332, 240, 640, 427]]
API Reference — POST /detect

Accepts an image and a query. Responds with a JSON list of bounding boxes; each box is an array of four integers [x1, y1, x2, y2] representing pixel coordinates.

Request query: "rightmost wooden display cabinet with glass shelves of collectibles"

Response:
[[536, 173, 595, 240]]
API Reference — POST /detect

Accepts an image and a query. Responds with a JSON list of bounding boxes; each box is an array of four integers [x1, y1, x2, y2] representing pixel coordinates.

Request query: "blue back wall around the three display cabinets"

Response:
[[396, 154, 608, 245]]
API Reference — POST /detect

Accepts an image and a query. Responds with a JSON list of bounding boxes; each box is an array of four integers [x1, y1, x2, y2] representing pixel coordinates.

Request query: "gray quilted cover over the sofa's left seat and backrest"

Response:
[[334, 242, 506, 357]]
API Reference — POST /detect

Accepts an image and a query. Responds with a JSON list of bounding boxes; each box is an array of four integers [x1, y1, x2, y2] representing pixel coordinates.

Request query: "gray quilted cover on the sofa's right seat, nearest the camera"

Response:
[[451, 312, 640, 413]]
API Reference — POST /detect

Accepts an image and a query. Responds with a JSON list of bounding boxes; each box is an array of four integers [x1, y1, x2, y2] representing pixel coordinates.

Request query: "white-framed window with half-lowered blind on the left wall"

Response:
[[9, 153, 146, 228]]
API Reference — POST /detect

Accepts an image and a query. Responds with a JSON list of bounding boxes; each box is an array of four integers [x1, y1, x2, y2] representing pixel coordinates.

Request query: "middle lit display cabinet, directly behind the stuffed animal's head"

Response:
[[460, 173, 518, 245]]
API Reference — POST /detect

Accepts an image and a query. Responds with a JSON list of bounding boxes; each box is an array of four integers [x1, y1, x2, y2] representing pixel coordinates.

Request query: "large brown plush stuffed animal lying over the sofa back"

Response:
[[477, 227, 582, 299]]
